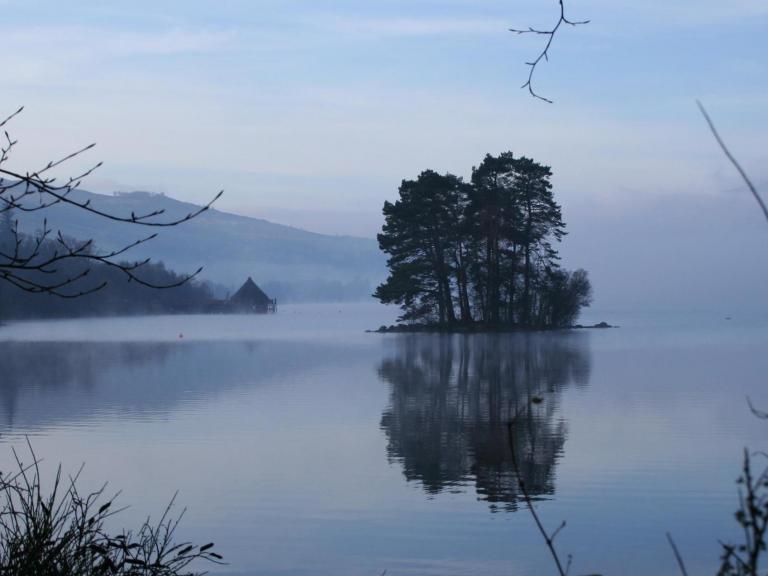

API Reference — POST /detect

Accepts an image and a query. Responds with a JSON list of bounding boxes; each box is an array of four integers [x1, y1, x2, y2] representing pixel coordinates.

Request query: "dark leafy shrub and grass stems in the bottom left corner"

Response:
[[0, 449, 222, 576]]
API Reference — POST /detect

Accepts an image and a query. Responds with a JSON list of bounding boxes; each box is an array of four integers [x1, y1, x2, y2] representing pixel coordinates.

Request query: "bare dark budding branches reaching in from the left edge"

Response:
[[0, 107, 222, 298]]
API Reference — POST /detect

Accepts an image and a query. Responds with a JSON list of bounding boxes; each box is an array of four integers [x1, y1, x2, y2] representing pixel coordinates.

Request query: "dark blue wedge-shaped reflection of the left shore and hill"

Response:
[[0, 340, 338, 433]]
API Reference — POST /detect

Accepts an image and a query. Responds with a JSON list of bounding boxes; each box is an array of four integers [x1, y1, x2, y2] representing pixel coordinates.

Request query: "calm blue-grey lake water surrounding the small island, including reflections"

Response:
[[0, 305, 768, 576]]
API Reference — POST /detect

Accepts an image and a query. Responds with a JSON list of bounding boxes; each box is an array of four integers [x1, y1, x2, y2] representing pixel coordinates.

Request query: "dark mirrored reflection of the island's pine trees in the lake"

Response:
[[379, 333, 590, 510]]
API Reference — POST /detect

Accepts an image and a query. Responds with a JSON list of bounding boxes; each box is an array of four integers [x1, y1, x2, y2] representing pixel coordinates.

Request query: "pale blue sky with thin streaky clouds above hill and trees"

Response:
[[0, 0, 768, 306]]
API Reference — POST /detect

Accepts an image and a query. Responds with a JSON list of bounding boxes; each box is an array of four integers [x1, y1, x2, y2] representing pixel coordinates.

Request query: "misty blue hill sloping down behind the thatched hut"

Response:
[[15, 190, 386, 301]]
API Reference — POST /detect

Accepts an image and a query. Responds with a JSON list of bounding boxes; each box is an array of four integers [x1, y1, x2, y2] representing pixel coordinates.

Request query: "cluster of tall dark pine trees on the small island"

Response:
[[374, 152, 592, 328]]
